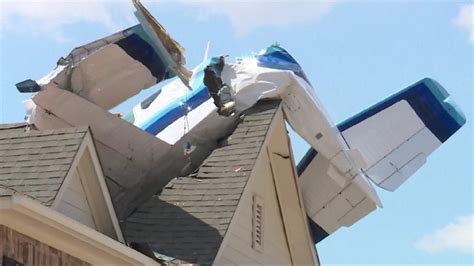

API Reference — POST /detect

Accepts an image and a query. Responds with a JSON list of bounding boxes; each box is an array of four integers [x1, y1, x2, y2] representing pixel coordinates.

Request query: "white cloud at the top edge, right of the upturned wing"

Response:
[[170, 0, 336, 35]]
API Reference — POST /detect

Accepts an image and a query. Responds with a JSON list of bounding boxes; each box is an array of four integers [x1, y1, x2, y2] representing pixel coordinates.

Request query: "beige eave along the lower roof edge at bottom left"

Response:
[[0, 194, 158, 265]]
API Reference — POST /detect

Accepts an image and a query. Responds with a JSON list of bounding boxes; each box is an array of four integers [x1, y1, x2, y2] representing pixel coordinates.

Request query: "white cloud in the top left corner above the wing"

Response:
[[0, 0, 131, 41]]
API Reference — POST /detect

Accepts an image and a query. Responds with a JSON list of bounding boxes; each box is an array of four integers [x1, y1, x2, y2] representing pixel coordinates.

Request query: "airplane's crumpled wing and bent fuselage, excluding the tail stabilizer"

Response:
[[17, 0, 381, 218]]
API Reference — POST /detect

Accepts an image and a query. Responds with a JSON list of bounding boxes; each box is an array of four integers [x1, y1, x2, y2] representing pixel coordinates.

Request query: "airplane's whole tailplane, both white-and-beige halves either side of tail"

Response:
[[298, 78, 466, 242]]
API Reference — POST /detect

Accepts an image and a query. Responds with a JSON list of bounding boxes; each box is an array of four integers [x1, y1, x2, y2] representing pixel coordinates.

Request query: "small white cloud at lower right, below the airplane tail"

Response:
[[415, 214, 474, 253]]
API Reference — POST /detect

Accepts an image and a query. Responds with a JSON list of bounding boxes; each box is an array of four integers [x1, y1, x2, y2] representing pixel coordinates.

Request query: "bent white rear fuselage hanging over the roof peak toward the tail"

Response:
[[222, 59, 382, 207]]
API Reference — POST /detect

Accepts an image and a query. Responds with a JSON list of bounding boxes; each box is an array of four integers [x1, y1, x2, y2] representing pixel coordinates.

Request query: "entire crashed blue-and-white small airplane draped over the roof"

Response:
[[17, 0, 466, 243]]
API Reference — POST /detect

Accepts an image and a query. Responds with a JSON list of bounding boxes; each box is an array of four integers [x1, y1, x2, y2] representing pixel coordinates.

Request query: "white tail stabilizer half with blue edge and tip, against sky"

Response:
[[338, 78, 466, 191]]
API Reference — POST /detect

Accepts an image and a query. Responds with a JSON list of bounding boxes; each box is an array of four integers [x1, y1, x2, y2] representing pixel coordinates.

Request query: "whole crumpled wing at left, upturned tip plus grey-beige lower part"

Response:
[[17, 1, 196, 217]]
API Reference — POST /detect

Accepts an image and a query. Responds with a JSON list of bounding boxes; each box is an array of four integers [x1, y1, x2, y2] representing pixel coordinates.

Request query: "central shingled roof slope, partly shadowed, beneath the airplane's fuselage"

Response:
[[122, 101, 279, 264]]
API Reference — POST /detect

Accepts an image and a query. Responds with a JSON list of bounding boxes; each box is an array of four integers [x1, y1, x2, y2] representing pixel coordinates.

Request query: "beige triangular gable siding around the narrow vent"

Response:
[[214, 154, 291, 265]]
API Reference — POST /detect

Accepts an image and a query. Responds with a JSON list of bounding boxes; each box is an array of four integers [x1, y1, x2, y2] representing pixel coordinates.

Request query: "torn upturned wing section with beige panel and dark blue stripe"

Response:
[[17, 0, 191, 110]]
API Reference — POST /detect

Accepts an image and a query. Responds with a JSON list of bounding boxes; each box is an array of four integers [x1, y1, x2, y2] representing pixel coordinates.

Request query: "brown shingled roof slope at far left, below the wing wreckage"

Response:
[[0, 123, 88, 206]]
